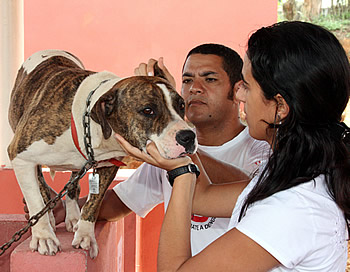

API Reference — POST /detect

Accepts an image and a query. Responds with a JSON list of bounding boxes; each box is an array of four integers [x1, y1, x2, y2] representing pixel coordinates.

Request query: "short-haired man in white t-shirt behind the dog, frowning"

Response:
[[26, 44, 268, 255]]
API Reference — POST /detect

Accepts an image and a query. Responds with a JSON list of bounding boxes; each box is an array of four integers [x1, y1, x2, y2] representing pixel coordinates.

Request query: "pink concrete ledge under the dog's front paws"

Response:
[[8, 220, 131, 272]]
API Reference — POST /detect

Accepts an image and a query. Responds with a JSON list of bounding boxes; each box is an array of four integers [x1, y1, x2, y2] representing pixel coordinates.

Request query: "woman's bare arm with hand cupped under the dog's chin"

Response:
[[116, 135, 279, 272]]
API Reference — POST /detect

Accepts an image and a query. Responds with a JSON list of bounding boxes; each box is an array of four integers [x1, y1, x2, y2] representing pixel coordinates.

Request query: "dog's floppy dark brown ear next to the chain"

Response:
[[90, 94, 116, 139]]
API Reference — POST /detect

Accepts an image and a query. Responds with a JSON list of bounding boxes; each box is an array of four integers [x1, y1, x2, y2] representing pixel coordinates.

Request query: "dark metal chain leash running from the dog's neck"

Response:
[[0, 83, 107, 256]]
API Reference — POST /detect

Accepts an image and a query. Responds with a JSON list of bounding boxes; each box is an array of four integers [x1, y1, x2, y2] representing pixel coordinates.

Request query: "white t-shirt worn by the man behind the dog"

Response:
[[114, 128, 269, 255]]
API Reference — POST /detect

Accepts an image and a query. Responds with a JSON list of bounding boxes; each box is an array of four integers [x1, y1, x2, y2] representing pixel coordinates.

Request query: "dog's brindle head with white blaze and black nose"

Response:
[[91, 76, 198, 158]]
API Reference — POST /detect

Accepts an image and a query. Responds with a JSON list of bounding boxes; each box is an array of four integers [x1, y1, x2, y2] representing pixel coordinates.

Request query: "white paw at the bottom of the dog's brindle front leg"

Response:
[[72, 220, 98, 259]]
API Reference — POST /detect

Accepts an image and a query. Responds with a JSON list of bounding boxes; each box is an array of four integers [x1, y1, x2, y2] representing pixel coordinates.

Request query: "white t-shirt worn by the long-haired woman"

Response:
[[229, 171, 348, 272]]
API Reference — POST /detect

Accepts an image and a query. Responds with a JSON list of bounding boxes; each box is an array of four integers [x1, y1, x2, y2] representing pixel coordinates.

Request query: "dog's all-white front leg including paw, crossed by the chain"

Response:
[[12, 157, 61, 255]]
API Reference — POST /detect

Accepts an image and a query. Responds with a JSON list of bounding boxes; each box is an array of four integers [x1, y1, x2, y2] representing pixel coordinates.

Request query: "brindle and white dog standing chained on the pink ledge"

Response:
[[8, 50, 197, 258]]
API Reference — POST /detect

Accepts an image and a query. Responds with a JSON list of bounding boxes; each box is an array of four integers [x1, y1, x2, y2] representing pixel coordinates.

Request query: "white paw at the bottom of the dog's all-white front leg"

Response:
[[29, 225, 61, 255]]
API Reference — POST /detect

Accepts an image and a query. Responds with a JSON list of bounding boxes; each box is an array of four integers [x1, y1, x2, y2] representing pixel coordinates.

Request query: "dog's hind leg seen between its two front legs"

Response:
[[65, 172, 80, 232]]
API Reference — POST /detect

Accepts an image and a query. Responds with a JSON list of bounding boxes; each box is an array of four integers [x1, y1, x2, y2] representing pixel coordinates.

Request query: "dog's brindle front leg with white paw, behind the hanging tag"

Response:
[[72, 166, 118, 259]]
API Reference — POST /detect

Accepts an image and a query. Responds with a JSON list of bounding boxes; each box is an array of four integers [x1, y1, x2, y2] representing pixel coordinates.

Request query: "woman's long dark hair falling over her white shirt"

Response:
[[240, 22, 350, 225]]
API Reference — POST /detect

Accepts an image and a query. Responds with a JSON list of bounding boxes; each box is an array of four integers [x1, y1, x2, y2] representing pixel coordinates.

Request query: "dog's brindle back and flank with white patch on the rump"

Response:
[[9, 50, 94, 159]]
